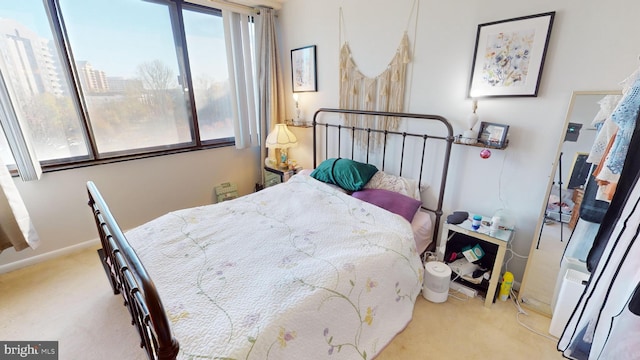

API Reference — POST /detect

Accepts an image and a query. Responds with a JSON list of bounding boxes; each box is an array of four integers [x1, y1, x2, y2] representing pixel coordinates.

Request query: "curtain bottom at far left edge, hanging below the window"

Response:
[[0, 155, 40, 252]]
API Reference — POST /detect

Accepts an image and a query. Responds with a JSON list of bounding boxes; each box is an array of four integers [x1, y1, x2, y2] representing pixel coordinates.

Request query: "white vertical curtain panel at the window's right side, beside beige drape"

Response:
[[222, 10, 260, 149]]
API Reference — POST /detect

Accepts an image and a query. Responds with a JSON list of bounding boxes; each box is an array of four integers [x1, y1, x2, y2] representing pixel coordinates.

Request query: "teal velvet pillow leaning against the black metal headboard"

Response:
[[311, 158, 378, 191]]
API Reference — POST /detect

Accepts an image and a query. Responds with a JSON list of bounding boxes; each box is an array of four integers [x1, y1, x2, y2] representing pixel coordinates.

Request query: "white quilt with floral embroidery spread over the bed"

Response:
[[126, 175, 423, 360]]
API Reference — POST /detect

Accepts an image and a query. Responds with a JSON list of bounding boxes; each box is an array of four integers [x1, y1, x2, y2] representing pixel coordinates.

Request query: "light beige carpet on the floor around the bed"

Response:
[[0, 249, 562, 360]]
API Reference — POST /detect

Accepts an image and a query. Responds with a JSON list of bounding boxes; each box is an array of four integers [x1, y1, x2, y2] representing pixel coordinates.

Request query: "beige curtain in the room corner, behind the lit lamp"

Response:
[[256, 8, 285, 182]]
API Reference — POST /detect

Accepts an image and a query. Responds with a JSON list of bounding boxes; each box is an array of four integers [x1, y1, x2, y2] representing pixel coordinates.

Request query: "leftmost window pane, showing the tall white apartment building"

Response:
[[0, 0, 89, 162]]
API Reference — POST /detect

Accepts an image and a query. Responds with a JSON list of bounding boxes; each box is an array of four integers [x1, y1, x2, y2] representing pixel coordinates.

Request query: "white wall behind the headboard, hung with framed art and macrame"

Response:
[[279, 0, 640, 280]]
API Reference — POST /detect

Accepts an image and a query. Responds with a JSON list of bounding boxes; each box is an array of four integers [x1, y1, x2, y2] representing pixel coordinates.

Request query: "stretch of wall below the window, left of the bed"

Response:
[[0, 147, 261, 272]]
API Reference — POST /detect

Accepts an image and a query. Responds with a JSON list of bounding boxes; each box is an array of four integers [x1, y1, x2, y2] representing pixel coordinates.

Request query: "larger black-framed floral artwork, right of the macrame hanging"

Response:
[[467, 12, 555, 98]]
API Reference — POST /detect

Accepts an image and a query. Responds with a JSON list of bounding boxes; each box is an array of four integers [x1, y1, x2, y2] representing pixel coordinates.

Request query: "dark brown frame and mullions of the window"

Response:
[[5, 0, 241, 175]]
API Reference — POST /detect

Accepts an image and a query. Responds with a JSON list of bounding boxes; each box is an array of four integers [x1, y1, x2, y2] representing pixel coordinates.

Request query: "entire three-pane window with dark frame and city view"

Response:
[[0, 0, 251, 169]]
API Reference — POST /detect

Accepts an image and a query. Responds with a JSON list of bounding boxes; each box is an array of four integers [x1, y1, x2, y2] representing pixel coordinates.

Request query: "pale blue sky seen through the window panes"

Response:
[[0, 0, 227, 80]]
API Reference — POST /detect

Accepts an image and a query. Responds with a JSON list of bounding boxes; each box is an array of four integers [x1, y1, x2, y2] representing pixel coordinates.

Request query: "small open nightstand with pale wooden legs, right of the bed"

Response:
[[437, 217, 515, 307]]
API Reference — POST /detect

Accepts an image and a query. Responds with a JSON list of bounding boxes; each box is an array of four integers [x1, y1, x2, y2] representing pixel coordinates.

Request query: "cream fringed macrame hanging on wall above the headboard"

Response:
[[340, 0, 419, 147]]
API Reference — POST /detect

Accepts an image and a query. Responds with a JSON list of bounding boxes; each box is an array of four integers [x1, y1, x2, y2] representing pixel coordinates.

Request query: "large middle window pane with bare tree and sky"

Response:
[[60, 0, 193, 154]]
